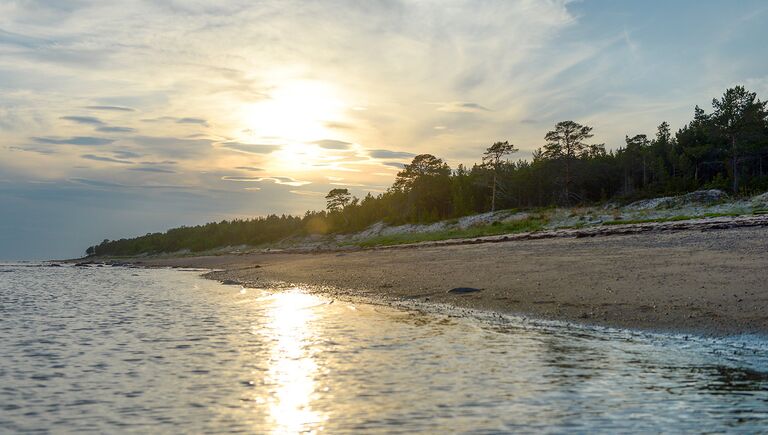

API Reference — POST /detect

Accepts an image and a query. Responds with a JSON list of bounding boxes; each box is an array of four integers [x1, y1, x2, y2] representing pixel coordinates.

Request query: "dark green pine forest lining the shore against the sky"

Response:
[[86, 86, 768, 256]]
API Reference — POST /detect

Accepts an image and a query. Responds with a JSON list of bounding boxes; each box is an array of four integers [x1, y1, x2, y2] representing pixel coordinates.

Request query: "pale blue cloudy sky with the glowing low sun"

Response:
[[0, 0, 768, 259]]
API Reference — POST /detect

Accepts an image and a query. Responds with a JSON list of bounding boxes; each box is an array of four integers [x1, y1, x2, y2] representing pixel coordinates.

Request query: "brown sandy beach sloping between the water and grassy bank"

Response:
[[126, 221, 768, 336]]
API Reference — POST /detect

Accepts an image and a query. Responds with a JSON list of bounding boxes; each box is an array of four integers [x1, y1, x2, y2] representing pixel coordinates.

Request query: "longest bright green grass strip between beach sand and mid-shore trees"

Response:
[[349, 217, 547, 248]]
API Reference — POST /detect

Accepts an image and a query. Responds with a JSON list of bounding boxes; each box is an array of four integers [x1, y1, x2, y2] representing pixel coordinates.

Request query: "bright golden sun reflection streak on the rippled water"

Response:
[[265, 289, 324, 434]]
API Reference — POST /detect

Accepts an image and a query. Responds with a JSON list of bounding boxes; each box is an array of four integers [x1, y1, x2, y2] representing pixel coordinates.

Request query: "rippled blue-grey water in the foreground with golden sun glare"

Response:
[[0, 265, 768, 433]]
